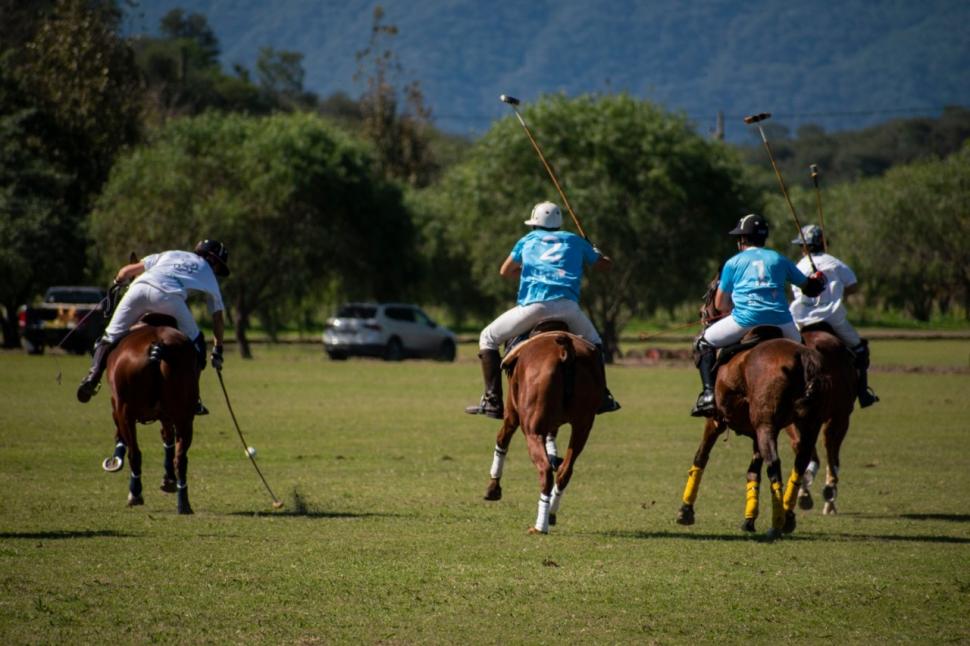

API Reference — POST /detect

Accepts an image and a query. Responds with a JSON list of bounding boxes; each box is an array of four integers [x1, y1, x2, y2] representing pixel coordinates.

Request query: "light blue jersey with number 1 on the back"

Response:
[[718, 247, 808, 327]]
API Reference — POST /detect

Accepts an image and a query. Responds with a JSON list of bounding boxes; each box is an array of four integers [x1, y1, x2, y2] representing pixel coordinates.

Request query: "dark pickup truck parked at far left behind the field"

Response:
[[18, 287, 106, 354]]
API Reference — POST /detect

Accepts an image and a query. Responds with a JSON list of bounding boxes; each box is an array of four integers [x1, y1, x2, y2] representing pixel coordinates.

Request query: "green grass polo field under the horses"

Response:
[[0, 341, 970, 644]]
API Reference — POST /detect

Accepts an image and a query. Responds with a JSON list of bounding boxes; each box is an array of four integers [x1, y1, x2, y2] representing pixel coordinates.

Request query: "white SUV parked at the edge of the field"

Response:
[[323, 303, 456, 361]]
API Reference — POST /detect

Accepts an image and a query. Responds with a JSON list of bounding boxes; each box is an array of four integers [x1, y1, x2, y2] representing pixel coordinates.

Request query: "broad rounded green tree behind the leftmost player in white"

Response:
[[91, 113, 415, 357]]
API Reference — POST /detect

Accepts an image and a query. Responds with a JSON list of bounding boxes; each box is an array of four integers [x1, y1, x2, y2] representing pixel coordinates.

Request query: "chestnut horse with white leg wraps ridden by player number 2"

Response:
[[485, 332, 606, 534]]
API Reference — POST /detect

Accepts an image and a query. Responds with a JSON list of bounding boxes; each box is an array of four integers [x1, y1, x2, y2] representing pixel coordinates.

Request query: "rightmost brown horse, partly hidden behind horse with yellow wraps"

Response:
[[798, 323, 858, 514]]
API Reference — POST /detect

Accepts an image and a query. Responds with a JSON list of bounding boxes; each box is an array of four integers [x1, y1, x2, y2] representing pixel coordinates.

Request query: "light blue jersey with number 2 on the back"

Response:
[[511, 229, 596, 312]]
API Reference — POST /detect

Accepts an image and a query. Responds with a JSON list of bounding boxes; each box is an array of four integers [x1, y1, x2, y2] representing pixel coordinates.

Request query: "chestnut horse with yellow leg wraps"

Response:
[[677, 279, 829, 538]]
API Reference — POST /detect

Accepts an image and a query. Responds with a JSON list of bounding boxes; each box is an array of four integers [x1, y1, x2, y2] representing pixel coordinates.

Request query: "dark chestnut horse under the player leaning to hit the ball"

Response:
[[107, 314, 199, 514]]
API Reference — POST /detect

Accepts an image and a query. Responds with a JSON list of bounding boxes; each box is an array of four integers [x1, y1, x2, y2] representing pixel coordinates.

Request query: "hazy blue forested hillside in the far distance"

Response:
[[126, 0, 970, 140]]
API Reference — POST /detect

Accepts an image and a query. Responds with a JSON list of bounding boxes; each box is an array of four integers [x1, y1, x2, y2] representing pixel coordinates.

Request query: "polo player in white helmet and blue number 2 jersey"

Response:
[[465, 202, 620, 419]]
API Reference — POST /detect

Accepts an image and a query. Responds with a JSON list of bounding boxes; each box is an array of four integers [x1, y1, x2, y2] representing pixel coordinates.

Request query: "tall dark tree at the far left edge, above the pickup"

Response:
[[0, 0, 141, 345]]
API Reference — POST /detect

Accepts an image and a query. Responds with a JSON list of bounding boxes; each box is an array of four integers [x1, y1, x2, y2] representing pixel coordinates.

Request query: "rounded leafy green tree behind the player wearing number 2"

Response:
[[415, 95, 758, 351]]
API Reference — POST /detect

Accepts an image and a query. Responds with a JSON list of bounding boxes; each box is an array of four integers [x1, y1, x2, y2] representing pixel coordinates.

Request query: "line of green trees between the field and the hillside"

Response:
[[0, 0, 970, 354]]
